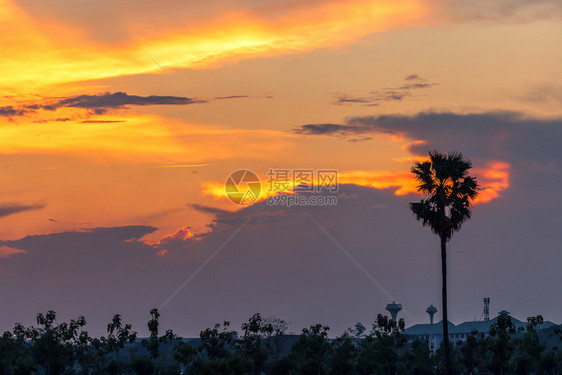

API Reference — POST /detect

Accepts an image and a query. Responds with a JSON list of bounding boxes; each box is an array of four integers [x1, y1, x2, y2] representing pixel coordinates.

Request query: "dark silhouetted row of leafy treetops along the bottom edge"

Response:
[[0, 309, 562, 375]]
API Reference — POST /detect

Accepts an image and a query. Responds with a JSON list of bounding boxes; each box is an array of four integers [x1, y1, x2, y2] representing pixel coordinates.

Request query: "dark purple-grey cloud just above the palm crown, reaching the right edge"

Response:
[[294, 112, 562, 166]]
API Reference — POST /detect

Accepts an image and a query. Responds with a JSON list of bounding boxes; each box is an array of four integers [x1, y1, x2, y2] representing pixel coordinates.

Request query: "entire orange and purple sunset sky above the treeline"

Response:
[[0, 0, 562, 336]]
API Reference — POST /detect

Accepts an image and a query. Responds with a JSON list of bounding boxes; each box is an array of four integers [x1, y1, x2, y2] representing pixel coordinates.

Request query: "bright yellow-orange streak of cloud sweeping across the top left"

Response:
[[0, 0, 426, 94]]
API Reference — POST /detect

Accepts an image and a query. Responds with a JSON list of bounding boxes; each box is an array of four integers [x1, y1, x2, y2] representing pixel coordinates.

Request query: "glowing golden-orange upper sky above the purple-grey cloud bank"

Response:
[[0, 0, 562, 334]]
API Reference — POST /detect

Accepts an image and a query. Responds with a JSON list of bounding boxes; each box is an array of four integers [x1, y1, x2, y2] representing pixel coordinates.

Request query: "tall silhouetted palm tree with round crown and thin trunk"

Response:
[[410, 151, 478, 374]]
